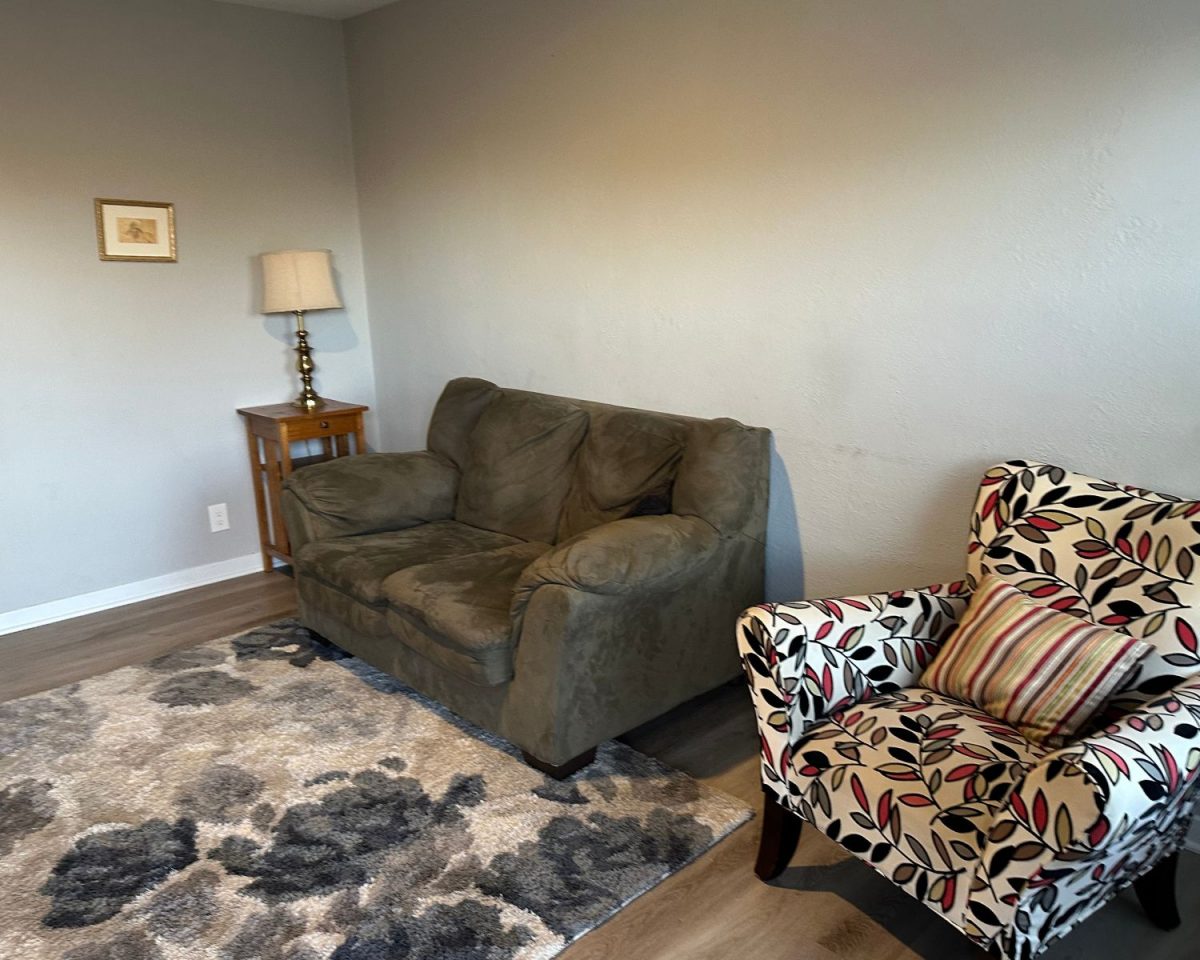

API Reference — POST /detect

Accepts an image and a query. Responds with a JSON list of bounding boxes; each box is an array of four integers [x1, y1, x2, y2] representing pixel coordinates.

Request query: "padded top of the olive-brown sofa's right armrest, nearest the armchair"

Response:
[[512, 514, 720, 616]]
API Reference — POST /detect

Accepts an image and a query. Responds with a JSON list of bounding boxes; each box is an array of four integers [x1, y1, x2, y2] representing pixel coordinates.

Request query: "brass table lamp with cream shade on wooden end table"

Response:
[[262, 250, 342, 410]]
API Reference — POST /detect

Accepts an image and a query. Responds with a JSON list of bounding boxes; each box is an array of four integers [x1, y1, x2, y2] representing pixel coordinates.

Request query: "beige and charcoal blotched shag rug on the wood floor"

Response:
[[0, 620, 749, 960]]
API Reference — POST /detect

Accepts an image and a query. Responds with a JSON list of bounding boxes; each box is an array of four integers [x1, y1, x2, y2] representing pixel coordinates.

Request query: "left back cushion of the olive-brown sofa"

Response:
[[455, 390, 588, 542]]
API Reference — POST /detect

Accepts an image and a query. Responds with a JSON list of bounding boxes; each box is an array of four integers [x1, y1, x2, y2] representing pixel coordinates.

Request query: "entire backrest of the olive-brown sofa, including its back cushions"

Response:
[[428, 378, 770, 542]]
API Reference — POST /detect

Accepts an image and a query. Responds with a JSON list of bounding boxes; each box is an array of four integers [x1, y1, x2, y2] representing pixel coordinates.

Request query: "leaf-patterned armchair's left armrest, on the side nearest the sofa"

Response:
[[738, 581, 970, 799]]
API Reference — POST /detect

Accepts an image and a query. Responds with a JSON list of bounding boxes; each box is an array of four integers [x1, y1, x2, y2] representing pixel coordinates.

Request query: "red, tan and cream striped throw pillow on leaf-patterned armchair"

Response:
[[920, 575, 1150, 746]]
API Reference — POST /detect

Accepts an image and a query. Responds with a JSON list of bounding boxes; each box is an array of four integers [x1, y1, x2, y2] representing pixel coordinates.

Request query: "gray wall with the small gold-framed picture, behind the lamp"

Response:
[[0, 0, 374, 612]]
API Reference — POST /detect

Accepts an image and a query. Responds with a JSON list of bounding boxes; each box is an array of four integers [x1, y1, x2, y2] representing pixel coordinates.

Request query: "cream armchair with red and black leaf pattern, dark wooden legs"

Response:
[[738, 461, 1200, 960]]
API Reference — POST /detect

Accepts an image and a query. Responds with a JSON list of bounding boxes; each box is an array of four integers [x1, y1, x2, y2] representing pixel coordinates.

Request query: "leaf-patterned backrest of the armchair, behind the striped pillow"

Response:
[[967, 460, 1200, 702]]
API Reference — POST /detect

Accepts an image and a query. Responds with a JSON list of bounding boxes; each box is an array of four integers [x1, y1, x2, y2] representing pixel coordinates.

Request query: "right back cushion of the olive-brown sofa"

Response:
[[558, 406, 688, 541]]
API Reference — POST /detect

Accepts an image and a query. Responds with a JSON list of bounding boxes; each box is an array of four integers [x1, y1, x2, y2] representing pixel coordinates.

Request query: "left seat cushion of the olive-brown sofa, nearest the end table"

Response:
[[293, 520, 520, 606]]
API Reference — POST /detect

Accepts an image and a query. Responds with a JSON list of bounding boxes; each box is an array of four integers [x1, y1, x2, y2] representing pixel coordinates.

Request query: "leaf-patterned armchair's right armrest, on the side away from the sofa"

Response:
[[966, 678, 1200, 955]]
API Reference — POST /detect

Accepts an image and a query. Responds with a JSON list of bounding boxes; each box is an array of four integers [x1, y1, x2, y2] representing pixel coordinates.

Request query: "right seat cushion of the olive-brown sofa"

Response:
[[383, 542, 551, 685]]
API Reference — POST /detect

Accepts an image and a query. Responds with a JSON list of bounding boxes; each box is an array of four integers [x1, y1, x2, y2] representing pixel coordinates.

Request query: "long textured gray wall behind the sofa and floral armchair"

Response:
[[347, 0, 1200, 598]]
